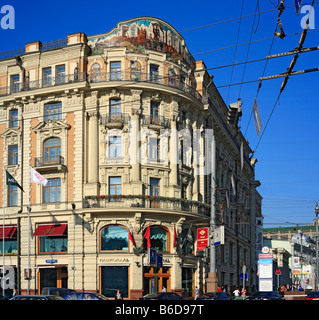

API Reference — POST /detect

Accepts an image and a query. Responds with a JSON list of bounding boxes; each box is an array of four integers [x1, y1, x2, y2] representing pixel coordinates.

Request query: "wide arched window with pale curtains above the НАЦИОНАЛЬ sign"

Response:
[[100, 225, 129, 251]]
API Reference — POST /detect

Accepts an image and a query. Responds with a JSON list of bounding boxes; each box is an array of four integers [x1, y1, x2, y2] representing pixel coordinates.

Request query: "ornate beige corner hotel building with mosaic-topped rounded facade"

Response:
[[0, 17, 260, 299]]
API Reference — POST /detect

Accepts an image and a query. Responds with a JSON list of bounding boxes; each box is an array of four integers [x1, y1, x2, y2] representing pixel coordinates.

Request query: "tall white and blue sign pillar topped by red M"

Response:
[[258, 253, 273, 291]]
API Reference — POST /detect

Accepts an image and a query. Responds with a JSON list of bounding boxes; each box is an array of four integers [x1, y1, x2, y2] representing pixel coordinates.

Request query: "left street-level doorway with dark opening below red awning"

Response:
[[38, 266, 68, 294]]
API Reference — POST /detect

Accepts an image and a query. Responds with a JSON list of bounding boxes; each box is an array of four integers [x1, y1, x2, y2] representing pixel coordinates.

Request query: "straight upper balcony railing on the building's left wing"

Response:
[[0, 72, 87, 96]]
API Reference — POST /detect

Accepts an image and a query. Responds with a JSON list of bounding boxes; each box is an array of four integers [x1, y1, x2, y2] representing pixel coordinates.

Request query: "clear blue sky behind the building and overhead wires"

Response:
[[0, 0, 319, 227]]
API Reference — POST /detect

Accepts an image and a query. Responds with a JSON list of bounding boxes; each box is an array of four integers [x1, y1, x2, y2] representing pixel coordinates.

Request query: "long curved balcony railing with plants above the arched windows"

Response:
[[83, 195, 210, 216]]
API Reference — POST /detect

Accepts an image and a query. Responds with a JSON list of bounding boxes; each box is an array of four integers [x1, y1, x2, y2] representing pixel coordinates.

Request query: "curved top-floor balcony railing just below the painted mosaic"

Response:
[[88, 71, 202, 101]]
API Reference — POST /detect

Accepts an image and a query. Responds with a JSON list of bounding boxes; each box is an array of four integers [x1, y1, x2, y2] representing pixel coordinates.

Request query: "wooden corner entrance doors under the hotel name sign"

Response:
[[144, 267, 171, 294]]
